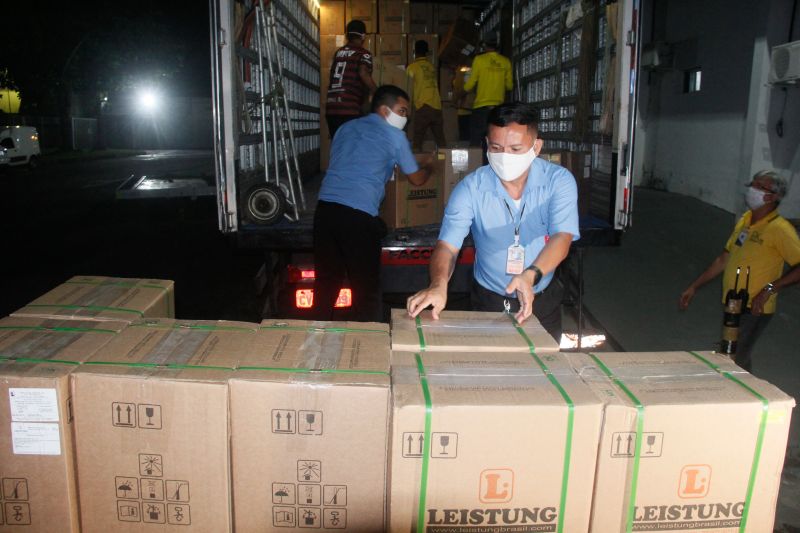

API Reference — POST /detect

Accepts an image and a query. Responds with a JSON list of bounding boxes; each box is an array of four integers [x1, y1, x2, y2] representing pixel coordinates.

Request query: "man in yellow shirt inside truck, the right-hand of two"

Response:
[[464, 41, 514, 146]]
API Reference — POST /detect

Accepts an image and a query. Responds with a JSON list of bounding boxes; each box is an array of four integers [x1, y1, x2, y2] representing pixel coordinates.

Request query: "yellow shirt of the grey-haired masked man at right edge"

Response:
[[722, 211, 800, 314]]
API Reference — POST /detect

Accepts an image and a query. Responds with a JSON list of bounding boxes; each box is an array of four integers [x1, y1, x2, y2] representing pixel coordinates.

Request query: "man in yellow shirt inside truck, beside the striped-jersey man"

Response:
[[406, 40, 446, 152]]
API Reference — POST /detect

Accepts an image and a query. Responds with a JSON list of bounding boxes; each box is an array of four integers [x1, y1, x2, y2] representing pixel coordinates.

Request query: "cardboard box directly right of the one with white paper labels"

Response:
[[72, 320, 257, 533]]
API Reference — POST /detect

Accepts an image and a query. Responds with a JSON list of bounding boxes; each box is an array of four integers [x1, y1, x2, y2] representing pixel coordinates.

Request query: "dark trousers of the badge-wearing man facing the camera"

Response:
[[470, 278, 564, 343]]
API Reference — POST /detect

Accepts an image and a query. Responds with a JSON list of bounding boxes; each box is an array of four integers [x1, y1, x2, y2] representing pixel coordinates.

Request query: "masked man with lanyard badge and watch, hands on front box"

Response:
[[407, 103, 579, 340]]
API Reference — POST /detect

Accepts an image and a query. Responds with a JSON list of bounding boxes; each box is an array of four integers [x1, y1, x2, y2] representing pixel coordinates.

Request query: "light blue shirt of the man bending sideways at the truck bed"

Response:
[[319, 113, 419, 216]]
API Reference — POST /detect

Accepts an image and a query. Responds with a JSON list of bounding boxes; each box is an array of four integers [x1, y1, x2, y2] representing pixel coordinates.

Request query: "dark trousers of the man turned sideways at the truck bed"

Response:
[[314, 200, 386, 322]]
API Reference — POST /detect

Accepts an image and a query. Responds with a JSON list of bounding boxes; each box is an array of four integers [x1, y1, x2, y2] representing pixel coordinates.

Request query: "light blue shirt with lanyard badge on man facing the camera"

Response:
[[439, 158, 580, 294]]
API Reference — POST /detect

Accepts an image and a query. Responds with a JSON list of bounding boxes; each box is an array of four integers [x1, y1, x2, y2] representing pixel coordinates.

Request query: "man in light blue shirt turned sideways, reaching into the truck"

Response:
[[313, 85, 432, 321]]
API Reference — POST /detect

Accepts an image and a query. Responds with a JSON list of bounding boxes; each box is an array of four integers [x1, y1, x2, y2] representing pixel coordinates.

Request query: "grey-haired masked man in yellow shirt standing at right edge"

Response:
[[679, 170, 800, 371]]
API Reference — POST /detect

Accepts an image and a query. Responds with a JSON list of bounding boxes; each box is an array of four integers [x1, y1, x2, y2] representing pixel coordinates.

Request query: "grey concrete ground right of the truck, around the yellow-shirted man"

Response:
[[584, 189, 800, 533]]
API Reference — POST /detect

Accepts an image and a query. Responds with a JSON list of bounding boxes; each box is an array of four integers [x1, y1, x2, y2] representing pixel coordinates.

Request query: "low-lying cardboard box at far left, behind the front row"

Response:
[[12, 276, 175, 322]]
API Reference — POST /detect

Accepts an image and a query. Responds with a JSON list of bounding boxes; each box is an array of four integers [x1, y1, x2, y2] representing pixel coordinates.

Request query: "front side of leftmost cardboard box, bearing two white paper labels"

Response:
[[0, 361, 80, 533]]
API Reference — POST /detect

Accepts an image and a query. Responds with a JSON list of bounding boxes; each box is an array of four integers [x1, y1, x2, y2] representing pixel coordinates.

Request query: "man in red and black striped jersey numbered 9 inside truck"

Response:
[[325, 20, 375, 139]]
